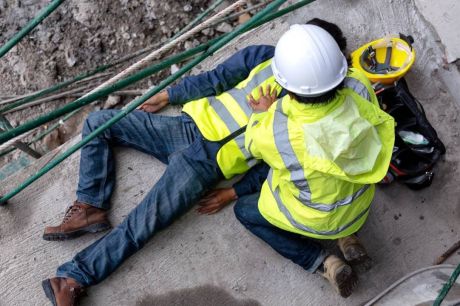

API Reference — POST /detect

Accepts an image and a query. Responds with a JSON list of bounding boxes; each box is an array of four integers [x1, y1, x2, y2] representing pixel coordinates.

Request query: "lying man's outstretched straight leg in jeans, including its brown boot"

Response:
[[43, 141, 222, 305]]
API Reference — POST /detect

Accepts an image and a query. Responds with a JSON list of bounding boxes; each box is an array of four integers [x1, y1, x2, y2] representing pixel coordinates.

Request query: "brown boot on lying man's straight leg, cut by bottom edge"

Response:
[[42, 277, 85, 306]]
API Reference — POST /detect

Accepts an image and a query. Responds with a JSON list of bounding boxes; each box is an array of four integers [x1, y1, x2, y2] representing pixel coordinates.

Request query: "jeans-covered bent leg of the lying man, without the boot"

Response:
[[77, 110, 197, 209]]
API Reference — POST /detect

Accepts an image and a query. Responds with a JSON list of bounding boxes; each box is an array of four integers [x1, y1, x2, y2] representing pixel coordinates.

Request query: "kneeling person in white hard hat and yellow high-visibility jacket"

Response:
[[241, 25, 394, 297]]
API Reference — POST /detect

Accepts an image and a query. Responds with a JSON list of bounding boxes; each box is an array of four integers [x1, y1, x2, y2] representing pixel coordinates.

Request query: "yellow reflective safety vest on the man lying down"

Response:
[[183, 59, 282, 179]]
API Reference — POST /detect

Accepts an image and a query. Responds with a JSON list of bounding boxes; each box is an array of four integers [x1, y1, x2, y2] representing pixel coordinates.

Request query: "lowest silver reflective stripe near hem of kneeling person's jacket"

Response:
[[267, 169, 370, 236]]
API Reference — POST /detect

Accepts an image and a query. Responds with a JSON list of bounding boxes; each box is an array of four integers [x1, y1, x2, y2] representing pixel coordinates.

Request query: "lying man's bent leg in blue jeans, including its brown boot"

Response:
[[43, 110, 201, 240]]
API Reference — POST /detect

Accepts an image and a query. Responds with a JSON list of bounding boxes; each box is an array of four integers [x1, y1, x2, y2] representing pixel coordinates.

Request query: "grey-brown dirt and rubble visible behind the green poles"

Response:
[[0, 0, 253, 166]]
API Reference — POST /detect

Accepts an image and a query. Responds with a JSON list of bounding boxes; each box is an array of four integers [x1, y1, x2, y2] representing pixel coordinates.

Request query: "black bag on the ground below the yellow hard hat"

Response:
[[376, 78, 446, 190]]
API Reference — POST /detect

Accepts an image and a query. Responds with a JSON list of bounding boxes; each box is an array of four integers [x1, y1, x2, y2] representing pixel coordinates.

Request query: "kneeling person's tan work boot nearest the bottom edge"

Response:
[[322, 255, 358, 298]]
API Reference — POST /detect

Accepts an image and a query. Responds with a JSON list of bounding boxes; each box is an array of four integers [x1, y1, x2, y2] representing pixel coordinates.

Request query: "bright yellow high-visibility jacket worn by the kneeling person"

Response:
[[246, 69, 394, 239]]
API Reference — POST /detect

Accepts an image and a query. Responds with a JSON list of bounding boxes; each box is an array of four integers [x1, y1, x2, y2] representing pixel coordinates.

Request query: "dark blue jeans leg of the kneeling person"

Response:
[[234, 193, 327, 273]]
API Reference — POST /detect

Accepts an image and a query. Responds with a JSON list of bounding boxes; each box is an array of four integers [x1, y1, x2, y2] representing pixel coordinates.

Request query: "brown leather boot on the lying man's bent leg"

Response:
[[43, 201, 111, 241]]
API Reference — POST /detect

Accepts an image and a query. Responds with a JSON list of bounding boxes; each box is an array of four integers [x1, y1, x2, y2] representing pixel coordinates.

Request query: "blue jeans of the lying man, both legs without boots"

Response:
[[56, 110, 222, 286]]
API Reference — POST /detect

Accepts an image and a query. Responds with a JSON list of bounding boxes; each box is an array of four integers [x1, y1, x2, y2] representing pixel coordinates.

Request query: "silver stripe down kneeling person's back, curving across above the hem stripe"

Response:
[[273, 100, 370, 212]]
